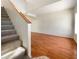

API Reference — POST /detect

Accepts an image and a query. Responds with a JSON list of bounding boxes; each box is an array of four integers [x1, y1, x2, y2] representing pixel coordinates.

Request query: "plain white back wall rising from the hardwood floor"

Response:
[[32, 9, 75, 37]]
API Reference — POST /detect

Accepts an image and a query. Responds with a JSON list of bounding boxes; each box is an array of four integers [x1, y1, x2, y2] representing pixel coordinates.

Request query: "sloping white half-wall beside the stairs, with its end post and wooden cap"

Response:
[[2, 0, 31, 57]]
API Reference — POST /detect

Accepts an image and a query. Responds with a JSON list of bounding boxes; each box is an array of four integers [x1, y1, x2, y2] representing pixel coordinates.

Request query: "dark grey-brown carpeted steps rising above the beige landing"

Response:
[[1, 7, 19, 43]]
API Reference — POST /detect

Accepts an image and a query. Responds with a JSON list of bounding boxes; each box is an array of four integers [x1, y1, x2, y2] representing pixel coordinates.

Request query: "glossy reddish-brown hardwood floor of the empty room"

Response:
[[32, 32, 77, 59]]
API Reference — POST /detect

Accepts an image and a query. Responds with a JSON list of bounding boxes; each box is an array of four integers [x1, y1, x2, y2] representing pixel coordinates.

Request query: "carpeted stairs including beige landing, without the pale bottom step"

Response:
[[1, 7, 21, 55]]
